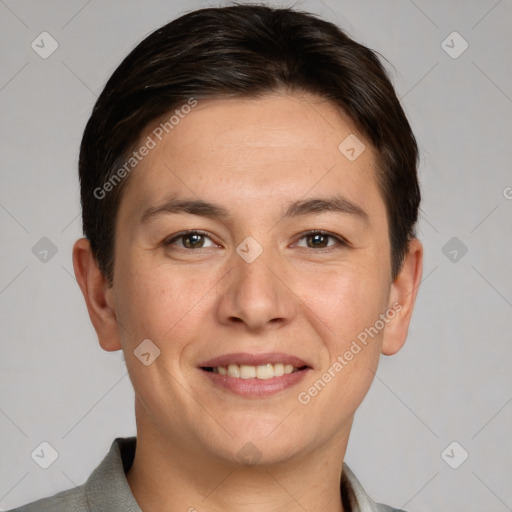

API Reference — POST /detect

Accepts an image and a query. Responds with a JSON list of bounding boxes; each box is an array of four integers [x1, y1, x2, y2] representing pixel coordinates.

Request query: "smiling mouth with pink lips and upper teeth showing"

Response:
[[199, 354, 313, 398]]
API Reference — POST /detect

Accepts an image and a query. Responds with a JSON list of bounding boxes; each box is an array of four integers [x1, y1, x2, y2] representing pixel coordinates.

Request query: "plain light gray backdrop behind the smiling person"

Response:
[[0, 0, 512, 512]]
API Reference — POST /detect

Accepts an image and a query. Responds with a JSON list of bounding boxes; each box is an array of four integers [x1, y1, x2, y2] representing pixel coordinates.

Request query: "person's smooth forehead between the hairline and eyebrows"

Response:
[[123, 94, 383, 221]]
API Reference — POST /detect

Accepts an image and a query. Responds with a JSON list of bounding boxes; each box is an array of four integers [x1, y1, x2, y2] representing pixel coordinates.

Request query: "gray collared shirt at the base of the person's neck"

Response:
[[10, 437, 404, 512]]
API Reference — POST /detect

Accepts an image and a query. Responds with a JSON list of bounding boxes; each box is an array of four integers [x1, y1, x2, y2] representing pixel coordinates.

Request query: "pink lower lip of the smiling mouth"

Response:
[[200, 368, 310, 398]]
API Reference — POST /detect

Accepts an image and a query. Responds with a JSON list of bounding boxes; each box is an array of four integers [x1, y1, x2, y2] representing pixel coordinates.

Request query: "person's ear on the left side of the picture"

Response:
[[73, 238, 121, 352]]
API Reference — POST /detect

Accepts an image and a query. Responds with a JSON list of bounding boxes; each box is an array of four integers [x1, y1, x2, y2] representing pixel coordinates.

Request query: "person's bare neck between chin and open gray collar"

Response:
[[127, 414, 348, 512]]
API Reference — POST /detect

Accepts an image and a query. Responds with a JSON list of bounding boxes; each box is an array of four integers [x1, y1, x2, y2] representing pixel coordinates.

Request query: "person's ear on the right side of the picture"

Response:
[[382, 238, 423, 356]]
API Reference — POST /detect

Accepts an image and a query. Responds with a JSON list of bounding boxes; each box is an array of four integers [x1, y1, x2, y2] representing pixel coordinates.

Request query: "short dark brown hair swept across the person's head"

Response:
[[79, 5, 420, 284]]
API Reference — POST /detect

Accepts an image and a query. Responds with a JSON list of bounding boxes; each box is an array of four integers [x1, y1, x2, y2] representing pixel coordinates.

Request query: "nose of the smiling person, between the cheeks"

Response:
[[218, 244, 297, 332]]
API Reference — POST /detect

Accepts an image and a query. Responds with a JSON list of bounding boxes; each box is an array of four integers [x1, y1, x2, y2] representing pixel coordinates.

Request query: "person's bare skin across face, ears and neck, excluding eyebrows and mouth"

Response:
[[73, 92, 423, 512]]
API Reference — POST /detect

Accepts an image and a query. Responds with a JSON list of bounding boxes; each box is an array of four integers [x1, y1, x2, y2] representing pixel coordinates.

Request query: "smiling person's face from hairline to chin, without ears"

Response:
[[95, 94, 416, 463]]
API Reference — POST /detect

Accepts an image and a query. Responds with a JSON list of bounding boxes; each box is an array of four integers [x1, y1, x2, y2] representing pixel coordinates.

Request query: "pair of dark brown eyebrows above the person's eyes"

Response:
[[140, 195, 369, 223]]
